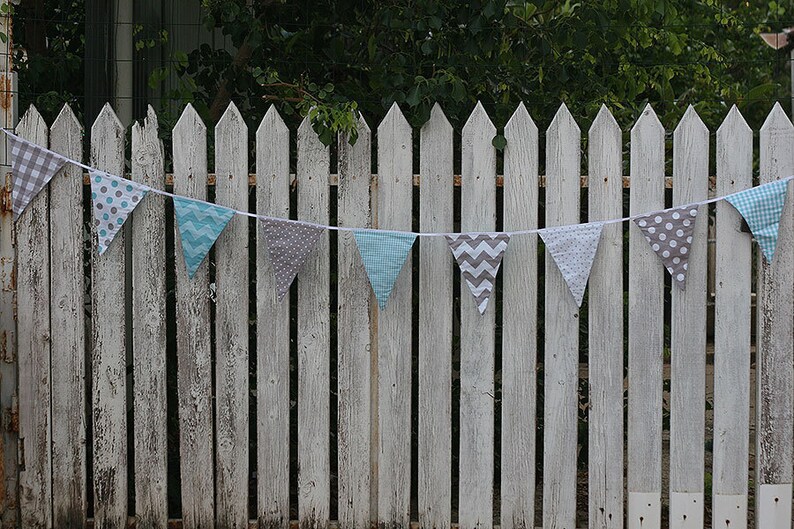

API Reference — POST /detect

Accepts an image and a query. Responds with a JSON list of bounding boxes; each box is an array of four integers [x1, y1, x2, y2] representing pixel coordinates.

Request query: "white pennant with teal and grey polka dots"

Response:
[[89, 171, 147, 255]]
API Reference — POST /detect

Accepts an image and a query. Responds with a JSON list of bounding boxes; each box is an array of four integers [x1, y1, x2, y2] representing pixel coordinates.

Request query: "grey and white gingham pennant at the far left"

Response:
[[7, 134, 67, 220]]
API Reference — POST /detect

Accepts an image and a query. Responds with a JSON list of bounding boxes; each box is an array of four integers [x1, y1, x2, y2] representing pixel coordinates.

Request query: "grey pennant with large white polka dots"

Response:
[[634, 206, 698, 290]]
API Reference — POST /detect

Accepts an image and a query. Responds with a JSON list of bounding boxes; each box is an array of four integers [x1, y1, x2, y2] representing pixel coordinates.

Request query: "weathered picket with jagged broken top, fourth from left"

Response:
[[130, 106, 168, 528]]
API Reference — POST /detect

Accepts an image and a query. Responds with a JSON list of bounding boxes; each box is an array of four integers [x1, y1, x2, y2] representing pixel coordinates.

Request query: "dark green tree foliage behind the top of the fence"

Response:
[[9, 0, 790, 139]]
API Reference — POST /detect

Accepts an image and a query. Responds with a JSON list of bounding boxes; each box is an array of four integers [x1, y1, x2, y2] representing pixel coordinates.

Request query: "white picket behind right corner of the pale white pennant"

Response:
[[587, 106, 623, 529]]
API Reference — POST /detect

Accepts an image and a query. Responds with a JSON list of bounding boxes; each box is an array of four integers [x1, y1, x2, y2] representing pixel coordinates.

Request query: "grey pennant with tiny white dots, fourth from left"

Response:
[[262, 219, 325, 301]]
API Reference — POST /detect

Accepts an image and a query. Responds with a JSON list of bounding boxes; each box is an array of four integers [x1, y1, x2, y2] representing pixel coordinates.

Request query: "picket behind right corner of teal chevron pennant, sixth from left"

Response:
[[215, 103, 248, 528]]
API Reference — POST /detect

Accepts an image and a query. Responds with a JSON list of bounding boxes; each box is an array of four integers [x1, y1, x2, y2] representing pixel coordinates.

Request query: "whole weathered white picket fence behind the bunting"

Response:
[[7, 100, 794, 529]]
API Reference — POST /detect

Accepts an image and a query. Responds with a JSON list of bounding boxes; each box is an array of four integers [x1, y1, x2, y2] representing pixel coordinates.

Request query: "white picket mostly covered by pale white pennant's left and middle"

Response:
[[543, 104, 581, 528]]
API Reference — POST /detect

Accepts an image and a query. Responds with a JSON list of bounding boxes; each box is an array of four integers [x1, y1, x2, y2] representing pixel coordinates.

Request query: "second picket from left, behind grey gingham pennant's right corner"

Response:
[[50, 105, 87, 527]]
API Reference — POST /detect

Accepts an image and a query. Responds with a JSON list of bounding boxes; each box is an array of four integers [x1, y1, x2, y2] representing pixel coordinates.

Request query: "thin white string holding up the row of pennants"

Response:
[[6, 129, 794, 237]]
